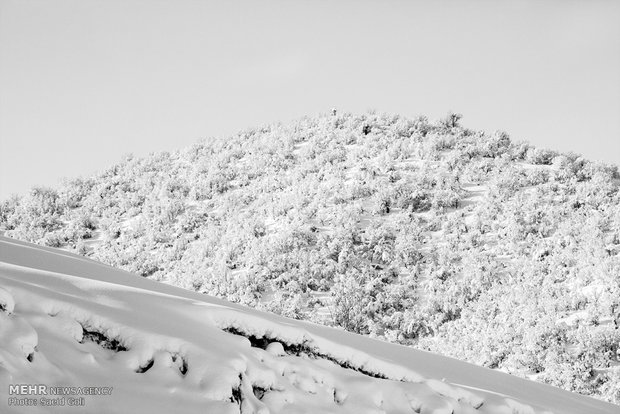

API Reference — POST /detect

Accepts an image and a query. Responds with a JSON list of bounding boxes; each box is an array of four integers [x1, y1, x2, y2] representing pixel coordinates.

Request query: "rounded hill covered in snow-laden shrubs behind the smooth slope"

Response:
[[0, 113, 620, 403]]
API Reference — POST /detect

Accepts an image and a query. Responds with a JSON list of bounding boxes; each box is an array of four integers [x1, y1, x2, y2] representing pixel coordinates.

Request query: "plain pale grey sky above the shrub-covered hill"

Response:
[[0, 0, 620, 199]]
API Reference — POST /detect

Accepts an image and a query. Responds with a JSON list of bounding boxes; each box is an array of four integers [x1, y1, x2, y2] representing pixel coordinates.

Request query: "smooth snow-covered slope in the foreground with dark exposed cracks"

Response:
[[0, 237, 618, 414]]
